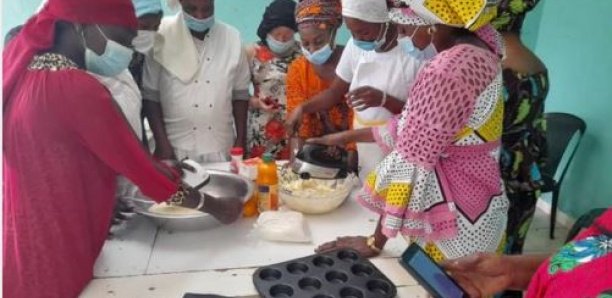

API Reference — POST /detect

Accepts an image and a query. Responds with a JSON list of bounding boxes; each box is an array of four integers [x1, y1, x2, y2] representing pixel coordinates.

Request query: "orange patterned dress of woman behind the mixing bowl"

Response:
[[286, 57, 356, 151]]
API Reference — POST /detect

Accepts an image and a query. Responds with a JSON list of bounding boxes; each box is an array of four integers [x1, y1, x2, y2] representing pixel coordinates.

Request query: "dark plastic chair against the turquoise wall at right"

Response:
[[542, 113, 586, 239]]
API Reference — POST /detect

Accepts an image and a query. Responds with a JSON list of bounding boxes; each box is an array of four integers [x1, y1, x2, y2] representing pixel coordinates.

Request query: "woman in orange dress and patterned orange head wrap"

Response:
[[287, 0, 357, 169]]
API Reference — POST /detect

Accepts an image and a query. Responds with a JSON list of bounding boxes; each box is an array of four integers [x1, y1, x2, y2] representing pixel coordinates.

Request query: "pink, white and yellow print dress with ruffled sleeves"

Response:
[[358, 45, 508, 261]]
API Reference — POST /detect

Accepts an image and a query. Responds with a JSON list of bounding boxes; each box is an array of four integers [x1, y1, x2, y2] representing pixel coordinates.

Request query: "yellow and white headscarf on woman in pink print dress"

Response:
[[392, 0, 500, 31]]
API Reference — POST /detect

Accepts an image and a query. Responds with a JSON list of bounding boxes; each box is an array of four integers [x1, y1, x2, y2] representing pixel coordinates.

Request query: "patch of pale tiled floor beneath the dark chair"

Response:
[[524, 209, 570, 253]]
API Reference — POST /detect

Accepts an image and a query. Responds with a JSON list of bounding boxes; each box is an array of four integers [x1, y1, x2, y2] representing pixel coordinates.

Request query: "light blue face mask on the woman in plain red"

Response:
[[81, 26, 134, 77]]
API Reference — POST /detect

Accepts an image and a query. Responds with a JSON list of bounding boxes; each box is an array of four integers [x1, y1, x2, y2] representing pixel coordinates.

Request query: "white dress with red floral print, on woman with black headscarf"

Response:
[[247, 45, 301, 159]]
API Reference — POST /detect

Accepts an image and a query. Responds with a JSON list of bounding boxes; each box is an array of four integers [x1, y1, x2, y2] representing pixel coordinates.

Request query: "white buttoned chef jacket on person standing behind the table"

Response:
[[143, 21, 251, 160]]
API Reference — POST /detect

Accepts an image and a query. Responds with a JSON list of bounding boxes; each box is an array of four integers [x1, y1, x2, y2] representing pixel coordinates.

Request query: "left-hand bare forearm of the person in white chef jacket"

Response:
[[142, 99, 176, 160]]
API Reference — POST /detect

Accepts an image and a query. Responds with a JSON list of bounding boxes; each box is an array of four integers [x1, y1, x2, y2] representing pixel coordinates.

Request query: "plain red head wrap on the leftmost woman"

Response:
[[2, 0, 138, 106]]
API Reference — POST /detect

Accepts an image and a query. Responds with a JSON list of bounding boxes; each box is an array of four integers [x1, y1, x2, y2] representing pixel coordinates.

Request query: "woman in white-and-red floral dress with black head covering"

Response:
[[246, 0, 300, 159]]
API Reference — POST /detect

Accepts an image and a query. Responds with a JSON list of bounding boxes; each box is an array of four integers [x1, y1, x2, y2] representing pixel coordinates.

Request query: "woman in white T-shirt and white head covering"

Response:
[[286, 0, 421, 178]]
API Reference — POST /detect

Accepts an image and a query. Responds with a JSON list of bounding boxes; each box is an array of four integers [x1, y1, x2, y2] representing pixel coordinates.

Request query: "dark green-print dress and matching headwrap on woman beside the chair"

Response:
[[492, 0, 550, 254]]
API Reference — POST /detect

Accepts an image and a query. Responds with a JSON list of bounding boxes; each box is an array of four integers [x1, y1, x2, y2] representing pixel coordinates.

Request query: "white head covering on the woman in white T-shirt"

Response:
[[342, 0, 389, 23]]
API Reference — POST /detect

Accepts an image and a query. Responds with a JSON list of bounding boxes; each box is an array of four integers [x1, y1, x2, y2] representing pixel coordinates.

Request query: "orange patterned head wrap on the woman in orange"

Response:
[[295, 0, 342, 30]]
